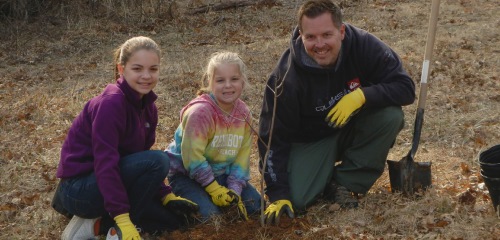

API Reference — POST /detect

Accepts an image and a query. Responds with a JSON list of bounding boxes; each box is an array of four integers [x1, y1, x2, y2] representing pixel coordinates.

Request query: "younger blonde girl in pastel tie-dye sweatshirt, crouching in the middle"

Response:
[[166, 52, 261, 219]]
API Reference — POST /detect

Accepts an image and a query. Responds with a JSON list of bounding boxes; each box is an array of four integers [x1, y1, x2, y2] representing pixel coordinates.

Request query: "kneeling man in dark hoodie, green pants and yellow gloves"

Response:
[[259, 0, 415, 223]]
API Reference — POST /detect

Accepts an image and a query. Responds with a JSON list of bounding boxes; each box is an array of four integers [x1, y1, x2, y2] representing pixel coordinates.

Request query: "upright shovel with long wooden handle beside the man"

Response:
[[387, 0, 440, 195]]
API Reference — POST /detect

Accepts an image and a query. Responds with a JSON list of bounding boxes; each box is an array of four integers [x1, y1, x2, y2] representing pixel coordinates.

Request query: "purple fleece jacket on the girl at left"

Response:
[[57, 78, 171, 217]]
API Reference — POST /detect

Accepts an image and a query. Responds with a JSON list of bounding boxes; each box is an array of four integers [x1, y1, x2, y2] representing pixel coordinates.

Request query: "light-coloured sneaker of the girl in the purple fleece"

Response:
[[61, 215, 97, 240]]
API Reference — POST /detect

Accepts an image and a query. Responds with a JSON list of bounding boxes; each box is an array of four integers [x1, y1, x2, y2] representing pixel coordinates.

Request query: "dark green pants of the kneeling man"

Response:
[[288, 107, 404, 211]]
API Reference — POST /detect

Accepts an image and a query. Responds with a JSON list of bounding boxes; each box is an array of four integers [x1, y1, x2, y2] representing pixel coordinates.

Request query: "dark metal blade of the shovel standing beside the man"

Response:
[[387, 156, 432, 195]]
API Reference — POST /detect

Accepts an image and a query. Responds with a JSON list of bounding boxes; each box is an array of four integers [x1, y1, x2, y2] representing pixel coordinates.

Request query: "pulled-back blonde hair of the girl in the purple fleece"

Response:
[[114, 36, 161, 79]]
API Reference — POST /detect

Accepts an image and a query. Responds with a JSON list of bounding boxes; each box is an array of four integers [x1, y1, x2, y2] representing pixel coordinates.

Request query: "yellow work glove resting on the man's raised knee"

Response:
[[325, 88, 366, 128]]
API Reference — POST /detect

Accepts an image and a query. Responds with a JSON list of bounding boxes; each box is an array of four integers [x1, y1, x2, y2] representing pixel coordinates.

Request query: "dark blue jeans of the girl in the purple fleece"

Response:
[[53, 150, 183, 233]]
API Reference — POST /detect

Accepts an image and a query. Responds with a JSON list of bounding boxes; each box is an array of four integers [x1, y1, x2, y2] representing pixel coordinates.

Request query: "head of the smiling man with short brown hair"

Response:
[[298, 0, 345, 67]]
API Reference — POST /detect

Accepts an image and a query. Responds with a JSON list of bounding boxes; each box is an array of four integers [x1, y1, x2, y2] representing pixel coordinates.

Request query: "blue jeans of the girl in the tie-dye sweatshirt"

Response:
[[168, 174, 261, 220]]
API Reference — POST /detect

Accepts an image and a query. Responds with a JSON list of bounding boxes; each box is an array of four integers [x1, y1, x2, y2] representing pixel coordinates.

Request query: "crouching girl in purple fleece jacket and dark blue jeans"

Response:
[[53, 37, 198, 240]]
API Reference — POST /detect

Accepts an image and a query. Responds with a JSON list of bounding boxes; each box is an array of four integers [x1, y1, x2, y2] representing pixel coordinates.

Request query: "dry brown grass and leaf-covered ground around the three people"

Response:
[[0, 0, 500, 239]]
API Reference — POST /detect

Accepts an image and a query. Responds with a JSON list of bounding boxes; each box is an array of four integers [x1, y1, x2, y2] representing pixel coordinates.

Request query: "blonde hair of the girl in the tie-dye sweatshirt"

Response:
[[196, 51, 250, 95]]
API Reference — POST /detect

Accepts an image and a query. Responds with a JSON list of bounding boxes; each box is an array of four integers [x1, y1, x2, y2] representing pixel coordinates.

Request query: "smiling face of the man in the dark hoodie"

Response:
[[300, 13, 345, 67]]
